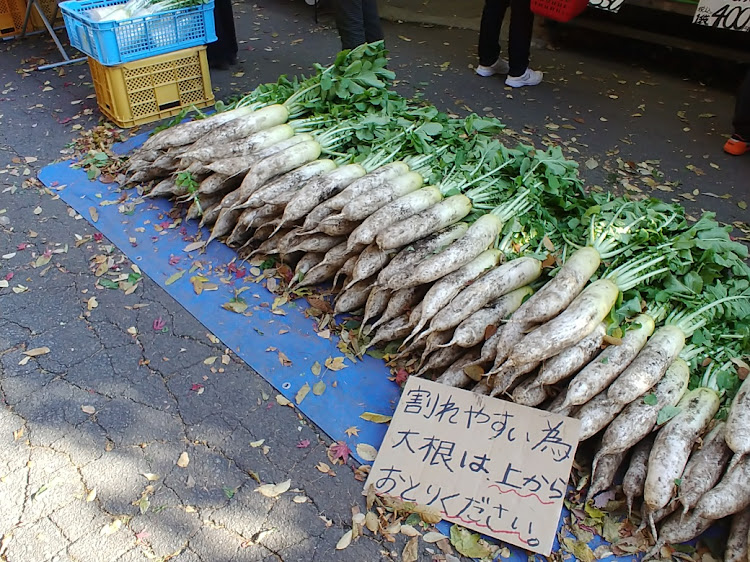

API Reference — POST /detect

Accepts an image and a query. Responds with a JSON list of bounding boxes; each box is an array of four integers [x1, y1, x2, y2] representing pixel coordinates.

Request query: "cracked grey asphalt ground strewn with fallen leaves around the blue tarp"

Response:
[[0, 0, 750, 562]]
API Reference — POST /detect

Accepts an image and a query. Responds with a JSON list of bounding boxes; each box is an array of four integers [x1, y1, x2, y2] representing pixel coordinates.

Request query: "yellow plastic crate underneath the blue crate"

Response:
[[90, 45, 214, 127]]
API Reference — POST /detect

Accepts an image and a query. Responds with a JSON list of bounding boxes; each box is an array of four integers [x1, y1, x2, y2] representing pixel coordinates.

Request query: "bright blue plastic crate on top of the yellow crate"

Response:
[[60, 0, 216, 66]]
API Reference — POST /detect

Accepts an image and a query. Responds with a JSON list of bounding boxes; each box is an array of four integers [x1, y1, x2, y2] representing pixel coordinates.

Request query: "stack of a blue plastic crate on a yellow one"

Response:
[[60, 0, 216, 127]]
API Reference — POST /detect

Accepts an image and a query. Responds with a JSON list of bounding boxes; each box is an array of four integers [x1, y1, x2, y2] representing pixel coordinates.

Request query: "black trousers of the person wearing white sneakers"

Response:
[[479, 0, 534, 76]]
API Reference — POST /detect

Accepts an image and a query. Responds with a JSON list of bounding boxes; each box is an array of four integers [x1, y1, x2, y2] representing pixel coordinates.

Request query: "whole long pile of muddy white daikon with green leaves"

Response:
[[123, 42, 750, 560]]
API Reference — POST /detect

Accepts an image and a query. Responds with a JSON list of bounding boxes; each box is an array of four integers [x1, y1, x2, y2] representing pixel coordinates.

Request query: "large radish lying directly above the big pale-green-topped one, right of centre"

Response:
[[511, 246, 601, 326]]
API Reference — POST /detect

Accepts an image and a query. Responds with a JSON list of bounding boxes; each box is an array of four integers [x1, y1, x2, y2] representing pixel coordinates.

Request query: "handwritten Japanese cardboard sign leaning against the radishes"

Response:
[[365, 377, 580, 556]]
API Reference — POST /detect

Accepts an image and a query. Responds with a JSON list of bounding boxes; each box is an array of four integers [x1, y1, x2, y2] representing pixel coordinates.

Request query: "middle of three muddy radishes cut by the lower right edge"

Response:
[[688, 455, 750, 520]]
